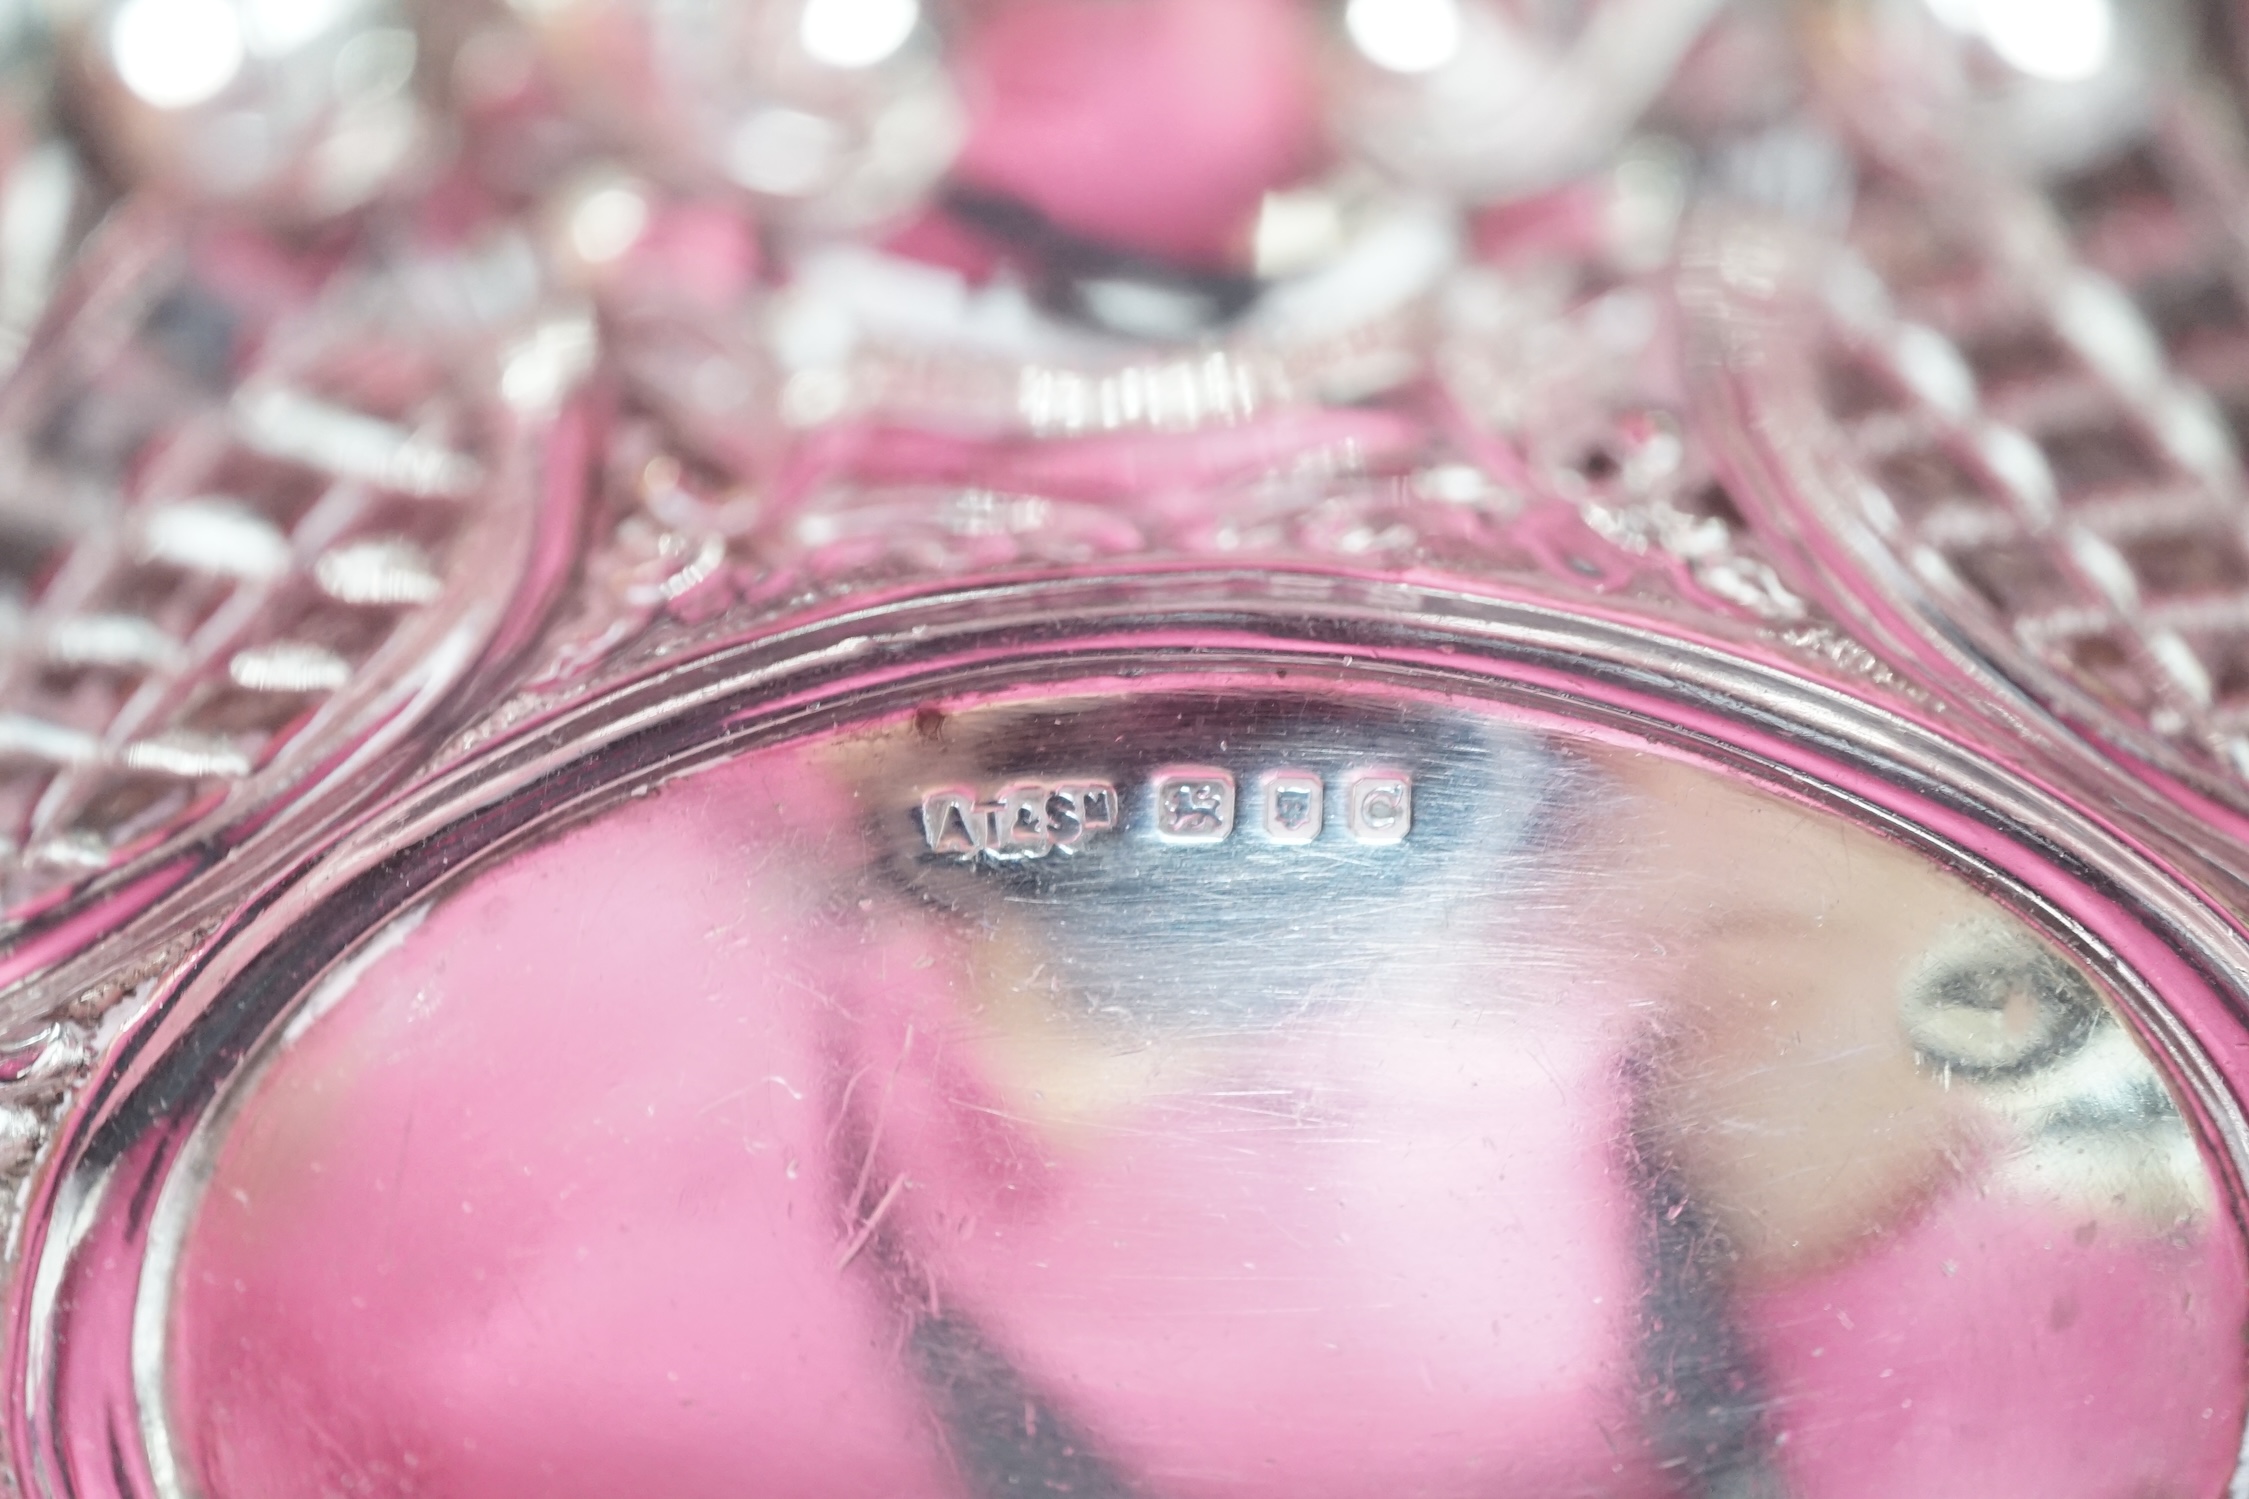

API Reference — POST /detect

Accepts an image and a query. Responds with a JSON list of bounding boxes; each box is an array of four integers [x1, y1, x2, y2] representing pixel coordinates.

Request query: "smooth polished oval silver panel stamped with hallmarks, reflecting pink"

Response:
[[40, 638, 2249, 1499]]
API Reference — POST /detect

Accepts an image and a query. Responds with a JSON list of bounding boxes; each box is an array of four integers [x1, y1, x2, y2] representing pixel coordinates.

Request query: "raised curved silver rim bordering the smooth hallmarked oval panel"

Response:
[[7, 571, 2249, 1499]]
